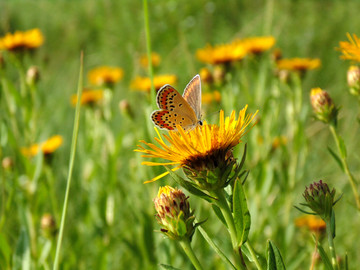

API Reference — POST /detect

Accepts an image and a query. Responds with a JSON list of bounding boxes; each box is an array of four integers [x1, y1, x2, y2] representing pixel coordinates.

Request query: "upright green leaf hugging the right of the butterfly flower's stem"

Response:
[[233, 180, 251, 246]]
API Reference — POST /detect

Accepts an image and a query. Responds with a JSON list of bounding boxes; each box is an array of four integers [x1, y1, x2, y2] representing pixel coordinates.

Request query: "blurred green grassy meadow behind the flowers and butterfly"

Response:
[[0, 0, 360, 269]]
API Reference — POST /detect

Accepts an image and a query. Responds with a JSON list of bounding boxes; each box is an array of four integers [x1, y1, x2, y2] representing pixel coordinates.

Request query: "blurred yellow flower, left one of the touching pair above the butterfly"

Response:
[[196, 40, 247, 65]]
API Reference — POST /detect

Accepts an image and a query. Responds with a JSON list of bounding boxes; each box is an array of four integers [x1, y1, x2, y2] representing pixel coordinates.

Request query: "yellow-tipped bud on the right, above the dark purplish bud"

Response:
[[310, 88, 338, 124]]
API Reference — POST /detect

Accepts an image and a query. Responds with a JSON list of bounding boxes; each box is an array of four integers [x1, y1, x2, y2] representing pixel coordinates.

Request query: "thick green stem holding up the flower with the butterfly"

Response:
[[213, 189, 247, 269]]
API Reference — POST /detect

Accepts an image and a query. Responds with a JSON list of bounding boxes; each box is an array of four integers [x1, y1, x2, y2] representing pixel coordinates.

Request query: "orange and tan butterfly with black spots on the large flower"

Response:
[[151, 75, 202, 131]]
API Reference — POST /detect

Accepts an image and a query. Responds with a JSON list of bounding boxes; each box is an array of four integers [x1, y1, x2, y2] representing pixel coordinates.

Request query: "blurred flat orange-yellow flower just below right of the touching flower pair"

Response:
[[276, 58, 321, 72]]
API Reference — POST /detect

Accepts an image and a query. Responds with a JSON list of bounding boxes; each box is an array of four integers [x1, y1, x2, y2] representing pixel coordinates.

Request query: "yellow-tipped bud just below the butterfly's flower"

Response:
[[154, 186, 195, 240]]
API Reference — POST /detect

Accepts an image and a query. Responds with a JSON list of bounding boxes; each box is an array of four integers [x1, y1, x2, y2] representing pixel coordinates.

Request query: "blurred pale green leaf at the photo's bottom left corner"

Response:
[[13, 228, 30, 270]]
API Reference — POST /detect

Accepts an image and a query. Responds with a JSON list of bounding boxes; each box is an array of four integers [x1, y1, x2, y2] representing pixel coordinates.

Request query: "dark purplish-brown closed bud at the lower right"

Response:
[[303, 180, 336, 220]]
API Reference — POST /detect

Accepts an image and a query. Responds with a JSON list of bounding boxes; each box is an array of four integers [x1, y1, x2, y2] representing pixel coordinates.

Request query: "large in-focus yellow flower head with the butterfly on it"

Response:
[[135, 106, 257, 183]]
